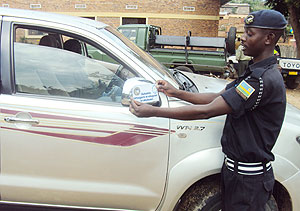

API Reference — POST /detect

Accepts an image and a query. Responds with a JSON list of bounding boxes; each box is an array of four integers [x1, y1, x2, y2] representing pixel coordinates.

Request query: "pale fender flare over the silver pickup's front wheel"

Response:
[[159, 151, 299, 211]]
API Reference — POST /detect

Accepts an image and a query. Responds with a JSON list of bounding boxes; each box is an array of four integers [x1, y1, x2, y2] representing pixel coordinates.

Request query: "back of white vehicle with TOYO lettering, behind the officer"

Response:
[[278, 58, 300, 89]]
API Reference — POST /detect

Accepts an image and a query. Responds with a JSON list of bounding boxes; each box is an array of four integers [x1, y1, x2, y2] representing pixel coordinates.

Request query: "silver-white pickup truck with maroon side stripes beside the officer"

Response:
[[0, 8, 300, 211]]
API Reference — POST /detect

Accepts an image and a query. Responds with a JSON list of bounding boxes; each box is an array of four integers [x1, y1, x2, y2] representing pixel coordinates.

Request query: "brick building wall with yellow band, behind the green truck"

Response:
[[0, 0, 220, 37]]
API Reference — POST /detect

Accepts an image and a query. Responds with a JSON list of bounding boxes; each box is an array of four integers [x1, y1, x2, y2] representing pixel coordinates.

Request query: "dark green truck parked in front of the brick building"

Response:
[[118, 24, 236, 78]]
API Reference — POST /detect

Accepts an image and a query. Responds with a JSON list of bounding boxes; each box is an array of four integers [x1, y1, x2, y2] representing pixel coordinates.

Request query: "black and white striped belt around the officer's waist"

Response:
[[225, 156, 272, 175]]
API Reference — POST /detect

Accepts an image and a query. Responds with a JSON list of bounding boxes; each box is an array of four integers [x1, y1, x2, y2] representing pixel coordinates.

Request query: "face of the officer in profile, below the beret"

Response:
[[241, 27, 266, 58]]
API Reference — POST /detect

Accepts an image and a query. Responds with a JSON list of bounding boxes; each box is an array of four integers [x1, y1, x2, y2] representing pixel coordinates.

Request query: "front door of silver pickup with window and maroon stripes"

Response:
[[0, 17, 169, 210]]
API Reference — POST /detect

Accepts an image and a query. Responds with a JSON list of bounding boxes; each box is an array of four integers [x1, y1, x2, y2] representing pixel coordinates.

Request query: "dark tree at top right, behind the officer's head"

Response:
[[265, 0, 300, 58]]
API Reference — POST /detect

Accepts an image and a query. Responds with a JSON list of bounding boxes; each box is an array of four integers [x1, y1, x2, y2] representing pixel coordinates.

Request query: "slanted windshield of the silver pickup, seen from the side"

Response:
[[100, 26, 178, 84]]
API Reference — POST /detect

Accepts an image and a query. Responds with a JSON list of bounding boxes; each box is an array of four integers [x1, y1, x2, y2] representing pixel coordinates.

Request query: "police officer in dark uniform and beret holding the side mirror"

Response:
[[130, 10, 287, 211]]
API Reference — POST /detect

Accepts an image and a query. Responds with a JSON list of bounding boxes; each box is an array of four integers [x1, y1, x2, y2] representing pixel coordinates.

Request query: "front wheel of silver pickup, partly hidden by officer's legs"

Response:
[[175, 175, 278, 211]]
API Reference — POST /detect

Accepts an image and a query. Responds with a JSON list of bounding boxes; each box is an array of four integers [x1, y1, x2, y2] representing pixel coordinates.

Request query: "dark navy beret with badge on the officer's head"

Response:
[[244, 10, 287, 29]]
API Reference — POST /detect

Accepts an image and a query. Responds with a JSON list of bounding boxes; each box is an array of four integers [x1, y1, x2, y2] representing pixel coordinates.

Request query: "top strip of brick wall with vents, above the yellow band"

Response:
[[4, 0, 220, 15]]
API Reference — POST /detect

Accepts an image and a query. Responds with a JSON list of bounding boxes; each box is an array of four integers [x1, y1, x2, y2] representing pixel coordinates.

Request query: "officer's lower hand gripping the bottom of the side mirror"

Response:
[[129, 99, 155, 117]]
